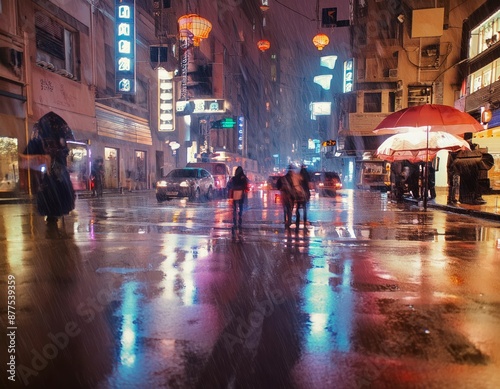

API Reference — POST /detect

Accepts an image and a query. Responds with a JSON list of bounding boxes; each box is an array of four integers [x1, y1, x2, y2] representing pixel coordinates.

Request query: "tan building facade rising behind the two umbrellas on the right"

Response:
[[328, 0, 492, 187]]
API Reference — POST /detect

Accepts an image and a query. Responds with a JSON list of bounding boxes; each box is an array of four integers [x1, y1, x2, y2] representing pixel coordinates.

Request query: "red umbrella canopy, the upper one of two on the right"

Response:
[[373, 104, 484, 135]]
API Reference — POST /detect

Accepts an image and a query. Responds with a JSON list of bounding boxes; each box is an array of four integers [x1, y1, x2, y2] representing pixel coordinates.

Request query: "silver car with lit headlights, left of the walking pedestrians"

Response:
[[156, 167, 215, 202]]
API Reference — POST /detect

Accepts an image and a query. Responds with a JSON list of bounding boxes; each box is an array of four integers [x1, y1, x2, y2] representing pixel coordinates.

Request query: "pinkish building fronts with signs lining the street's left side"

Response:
[[0, 0, 288, 193]]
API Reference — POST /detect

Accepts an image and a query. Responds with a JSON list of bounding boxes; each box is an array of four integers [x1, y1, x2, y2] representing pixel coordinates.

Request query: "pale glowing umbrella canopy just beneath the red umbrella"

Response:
[[376, 130, 470, 163]]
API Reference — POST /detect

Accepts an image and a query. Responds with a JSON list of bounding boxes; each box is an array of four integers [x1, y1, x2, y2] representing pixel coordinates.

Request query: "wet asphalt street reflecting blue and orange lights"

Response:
[[0, 190, 500, 389]]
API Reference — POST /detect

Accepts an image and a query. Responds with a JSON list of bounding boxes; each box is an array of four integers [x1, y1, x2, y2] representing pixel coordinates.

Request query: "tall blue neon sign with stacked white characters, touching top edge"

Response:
[[115, 0, 135, 94]]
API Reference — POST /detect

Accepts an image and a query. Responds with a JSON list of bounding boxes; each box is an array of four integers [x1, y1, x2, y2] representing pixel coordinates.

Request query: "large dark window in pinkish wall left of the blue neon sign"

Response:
[[35, 11, 76, 78]]
